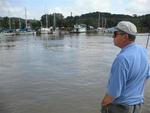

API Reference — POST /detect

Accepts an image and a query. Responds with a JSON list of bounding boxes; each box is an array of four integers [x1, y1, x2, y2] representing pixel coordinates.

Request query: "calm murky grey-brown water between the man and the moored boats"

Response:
[[0, 34, 150, 113]]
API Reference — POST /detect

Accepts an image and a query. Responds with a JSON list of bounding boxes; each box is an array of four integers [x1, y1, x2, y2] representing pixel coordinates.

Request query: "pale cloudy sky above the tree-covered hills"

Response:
[[0, 0, 150, 20]]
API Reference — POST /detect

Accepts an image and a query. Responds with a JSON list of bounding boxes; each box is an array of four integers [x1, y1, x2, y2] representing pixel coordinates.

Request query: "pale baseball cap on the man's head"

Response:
[[115, 21, 137, 35]]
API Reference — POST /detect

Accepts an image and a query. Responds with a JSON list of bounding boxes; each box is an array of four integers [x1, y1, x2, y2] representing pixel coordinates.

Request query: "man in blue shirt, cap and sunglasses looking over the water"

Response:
[[101, 21, 150, 113]]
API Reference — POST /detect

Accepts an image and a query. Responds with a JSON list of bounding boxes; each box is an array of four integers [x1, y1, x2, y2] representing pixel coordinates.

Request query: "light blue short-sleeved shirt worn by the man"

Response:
[[107, 43, 150, 105]]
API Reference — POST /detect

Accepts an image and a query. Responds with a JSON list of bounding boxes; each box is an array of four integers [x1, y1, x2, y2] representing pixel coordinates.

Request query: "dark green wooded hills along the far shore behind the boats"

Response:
[[0, 12, 150, 32]]
